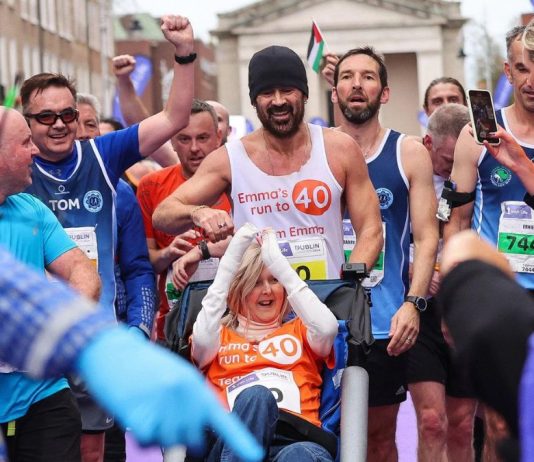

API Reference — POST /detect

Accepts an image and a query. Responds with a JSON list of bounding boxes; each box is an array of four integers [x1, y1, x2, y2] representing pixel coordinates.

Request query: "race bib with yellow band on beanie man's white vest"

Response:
[[278, 237, 327, 281]]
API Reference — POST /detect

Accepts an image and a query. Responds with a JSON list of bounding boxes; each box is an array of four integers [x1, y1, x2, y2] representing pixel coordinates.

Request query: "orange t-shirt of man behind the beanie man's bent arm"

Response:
[[137, 165, 231, 340]]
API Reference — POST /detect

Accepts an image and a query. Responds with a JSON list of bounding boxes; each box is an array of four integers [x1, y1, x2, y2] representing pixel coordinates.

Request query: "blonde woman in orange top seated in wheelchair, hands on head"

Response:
[[191, 223, 338, 462]]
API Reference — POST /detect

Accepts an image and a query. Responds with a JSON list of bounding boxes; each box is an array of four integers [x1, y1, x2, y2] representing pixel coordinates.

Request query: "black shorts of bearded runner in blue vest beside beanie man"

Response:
[[362, 339, 406, 407]]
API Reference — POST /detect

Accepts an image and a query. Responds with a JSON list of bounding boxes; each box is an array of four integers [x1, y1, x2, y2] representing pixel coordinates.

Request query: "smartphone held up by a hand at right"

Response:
[[467, 90, 501, 145]]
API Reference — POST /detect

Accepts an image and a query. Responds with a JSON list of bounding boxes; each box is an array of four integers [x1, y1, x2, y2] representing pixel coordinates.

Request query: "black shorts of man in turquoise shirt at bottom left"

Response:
[[2, 388, 82, 462]]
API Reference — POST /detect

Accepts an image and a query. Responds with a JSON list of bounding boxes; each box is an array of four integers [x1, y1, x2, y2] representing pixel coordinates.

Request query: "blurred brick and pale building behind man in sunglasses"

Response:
[[0, 0, 114, 110]]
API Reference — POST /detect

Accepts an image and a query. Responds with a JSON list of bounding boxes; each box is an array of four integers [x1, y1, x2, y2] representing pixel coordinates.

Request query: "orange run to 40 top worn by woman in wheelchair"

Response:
[[205, 318, 334, 427]]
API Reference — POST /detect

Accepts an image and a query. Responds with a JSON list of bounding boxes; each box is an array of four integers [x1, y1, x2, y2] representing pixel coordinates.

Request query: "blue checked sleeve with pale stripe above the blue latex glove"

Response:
[[0, 246, 115, 378]]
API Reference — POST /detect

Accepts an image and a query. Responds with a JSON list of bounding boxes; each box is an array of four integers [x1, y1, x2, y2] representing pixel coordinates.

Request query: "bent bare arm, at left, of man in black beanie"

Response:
[[152, 146, 234, 242]]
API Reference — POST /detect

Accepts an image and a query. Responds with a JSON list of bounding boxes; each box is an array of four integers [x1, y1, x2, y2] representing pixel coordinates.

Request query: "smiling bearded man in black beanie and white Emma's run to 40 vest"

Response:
[[153, 46, 382, 279]]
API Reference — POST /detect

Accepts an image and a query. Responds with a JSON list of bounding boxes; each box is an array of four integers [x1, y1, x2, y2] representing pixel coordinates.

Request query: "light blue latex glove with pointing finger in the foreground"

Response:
[[76, 326, 263, 461]]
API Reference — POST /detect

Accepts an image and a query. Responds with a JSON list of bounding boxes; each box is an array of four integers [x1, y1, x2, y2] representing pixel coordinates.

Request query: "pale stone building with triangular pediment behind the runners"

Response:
[[212, 0, 464, 134]]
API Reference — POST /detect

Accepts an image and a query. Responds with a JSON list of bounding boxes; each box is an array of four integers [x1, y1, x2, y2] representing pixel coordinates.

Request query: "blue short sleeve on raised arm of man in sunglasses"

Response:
[[95, 124, 143, 185]]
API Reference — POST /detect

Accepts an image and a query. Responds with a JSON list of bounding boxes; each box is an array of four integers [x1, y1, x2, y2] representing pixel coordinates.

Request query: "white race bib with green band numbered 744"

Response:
[[497, 201, 534, 273]]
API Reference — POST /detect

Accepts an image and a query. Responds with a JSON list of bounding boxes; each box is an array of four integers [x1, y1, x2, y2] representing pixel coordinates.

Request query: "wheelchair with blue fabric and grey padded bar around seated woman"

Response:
[[164, 264, 374, 462]]
